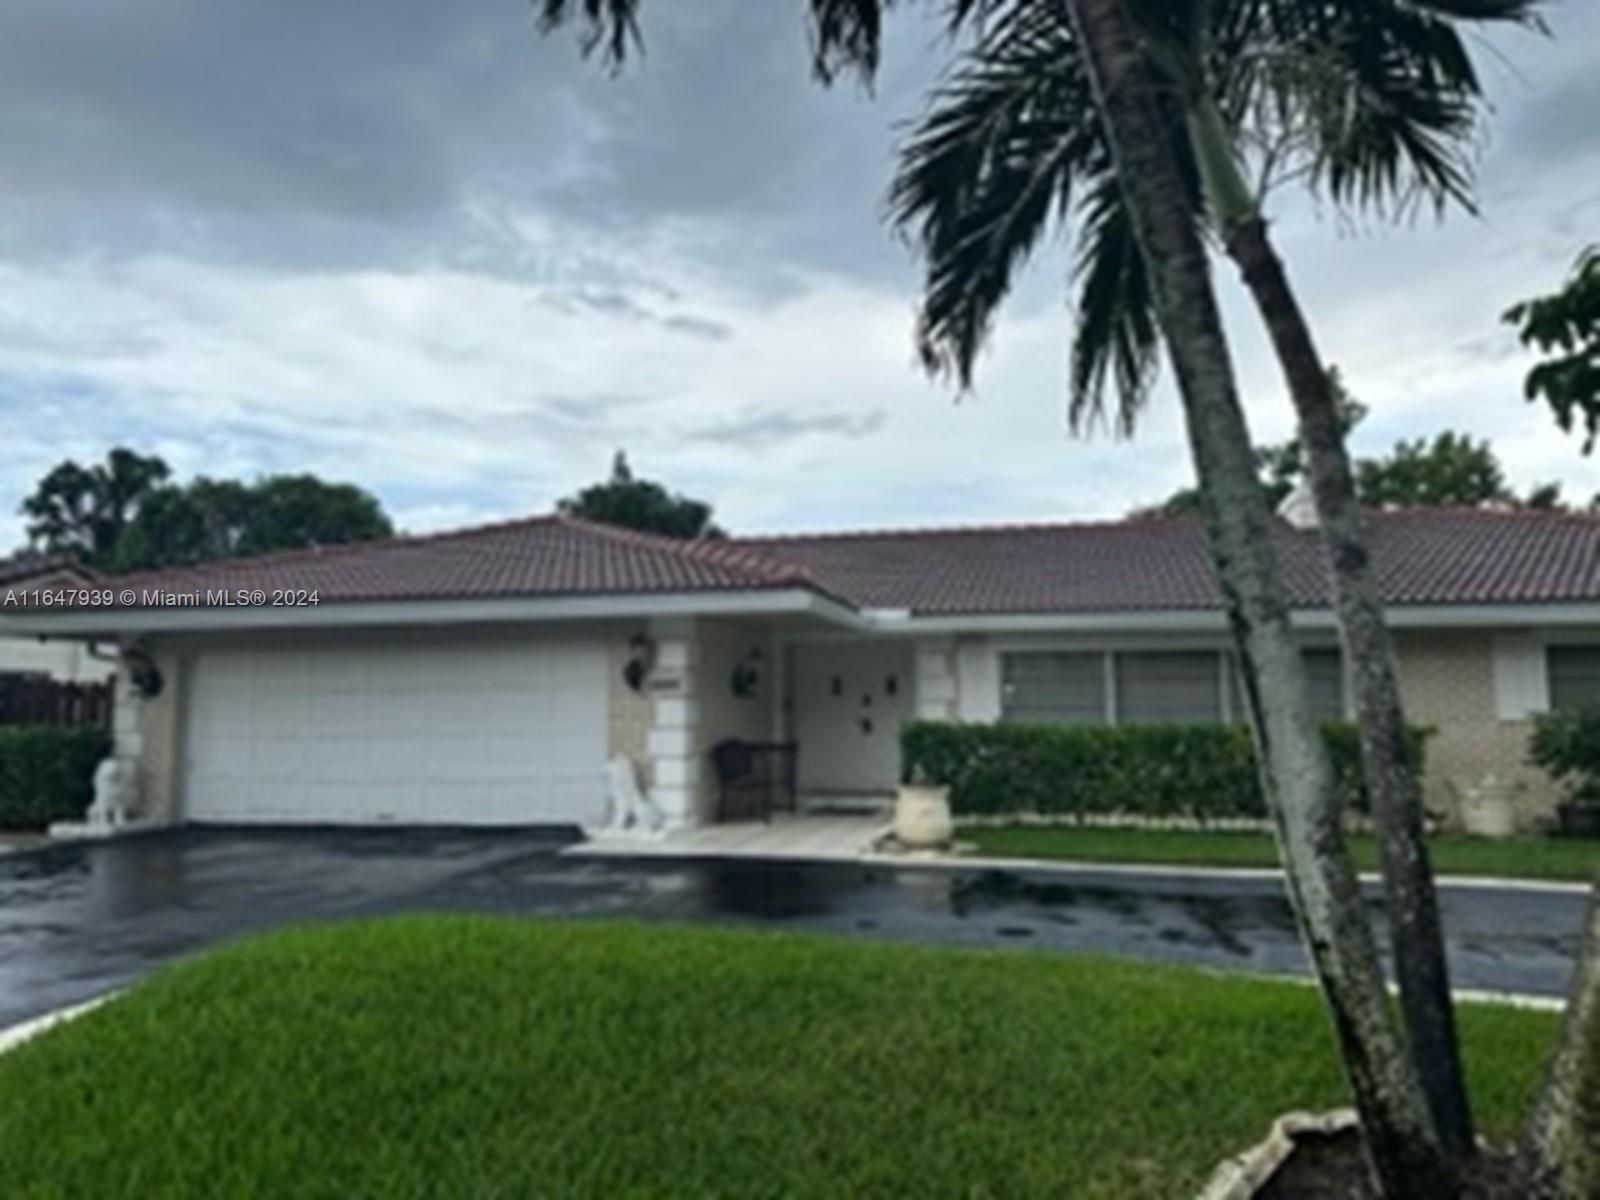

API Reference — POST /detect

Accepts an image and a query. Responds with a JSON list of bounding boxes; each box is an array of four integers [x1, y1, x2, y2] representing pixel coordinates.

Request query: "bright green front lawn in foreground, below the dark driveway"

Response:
[[0, 917, 1554, 1200]]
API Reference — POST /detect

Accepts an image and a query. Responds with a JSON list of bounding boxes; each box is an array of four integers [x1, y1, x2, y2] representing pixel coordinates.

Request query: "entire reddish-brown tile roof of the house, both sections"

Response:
[[12, 509, 1600, 614]]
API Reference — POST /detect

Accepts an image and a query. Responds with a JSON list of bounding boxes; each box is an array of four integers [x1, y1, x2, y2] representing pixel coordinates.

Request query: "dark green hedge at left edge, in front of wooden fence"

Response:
[[0, 725, 110, 829]]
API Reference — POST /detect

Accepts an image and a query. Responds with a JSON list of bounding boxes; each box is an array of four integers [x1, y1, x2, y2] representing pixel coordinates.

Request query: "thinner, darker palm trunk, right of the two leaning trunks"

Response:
[[1224, 213, 1474, 1158]]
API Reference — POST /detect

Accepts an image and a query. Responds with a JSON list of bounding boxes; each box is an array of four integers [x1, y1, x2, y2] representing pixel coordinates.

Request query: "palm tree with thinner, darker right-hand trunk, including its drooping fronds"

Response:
[[891, 0, 1534, 1155]]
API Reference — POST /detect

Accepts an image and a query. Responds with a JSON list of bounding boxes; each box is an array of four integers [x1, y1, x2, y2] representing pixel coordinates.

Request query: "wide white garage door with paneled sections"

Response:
[[184, 640, 605, 824]]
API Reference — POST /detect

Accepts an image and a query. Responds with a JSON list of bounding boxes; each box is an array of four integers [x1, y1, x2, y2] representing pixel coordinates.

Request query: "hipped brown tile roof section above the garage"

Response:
[[65, 517, 822, 603]]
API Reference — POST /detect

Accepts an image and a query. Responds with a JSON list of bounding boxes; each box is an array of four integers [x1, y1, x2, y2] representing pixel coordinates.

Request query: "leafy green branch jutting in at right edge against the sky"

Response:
[[1506, 245, 1600, 454]]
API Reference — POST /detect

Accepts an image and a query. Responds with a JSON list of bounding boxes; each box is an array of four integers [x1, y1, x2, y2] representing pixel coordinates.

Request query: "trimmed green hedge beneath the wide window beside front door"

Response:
[[901, 722, 1427, 821]]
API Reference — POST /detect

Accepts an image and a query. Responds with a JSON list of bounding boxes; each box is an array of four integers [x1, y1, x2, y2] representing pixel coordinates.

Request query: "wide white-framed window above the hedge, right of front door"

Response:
[[1000, 648, 1344, 725]]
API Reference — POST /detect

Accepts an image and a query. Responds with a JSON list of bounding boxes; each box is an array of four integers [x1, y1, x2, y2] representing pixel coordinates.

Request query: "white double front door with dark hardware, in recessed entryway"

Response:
[[790, 640, 915, 795]]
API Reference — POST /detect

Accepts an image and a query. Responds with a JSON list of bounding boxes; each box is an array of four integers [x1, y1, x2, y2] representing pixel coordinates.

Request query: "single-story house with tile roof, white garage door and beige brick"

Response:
[[0, 509, 1600, 827]]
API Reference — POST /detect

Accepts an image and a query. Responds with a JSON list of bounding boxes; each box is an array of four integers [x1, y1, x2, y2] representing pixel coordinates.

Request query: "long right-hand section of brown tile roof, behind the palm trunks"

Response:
[[742, 509, 1600, 614]]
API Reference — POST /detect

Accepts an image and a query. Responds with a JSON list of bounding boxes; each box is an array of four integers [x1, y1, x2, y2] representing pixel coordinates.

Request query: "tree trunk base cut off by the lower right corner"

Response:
[[1526, 878, 1600, 1200]]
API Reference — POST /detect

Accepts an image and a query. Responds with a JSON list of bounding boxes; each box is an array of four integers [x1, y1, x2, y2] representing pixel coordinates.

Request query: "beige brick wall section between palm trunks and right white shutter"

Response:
[[1395, 630, 1558, 826]]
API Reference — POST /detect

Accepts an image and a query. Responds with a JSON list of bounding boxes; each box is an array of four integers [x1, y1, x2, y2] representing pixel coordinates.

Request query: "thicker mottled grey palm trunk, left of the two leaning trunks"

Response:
[[1058, 0, 1459, 1200]]
